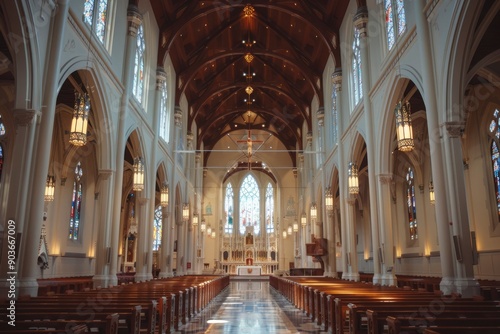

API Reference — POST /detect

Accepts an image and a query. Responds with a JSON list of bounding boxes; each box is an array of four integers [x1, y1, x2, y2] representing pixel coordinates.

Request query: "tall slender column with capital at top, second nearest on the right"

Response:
[[354, 7, 381, 284]]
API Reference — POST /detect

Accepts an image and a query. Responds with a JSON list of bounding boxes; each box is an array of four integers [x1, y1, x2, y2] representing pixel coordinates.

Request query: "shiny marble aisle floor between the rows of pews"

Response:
[[177, 280, 326, 334]]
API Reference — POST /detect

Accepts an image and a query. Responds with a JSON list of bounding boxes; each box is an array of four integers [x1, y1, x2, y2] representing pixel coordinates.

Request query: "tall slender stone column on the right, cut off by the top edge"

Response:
[[413, 0, 455, 295]]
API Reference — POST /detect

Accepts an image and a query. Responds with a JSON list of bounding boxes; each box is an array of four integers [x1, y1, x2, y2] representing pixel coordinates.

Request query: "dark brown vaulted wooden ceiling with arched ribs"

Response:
[[151, 0, 349, 164]]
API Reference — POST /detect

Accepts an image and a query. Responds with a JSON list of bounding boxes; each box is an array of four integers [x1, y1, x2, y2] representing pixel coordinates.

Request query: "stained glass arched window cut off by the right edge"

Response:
[[488, 109, 500, 222]]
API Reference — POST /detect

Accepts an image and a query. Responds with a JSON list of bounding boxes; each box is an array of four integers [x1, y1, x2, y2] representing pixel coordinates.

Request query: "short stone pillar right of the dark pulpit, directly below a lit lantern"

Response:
[[342, 197, 359, 282]]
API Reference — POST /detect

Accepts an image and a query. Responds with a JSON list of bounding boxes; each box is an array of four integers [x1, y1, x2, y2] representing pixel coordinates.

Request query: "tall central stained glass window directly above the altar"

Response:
[[240, 174, 260, 235]]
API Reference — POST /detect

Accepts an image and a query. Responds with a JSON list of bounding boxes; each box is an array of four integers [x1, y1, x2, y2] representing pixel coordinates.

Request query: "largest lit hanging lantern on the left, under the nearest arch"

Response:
[[69, 92, 90, 146]]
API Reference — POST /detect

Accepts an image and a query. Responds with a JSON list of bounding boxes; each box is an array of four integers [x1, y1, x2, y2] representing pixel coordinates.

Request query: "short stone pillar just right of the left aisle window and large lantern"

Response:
[[92, 169, 113, 288]]
